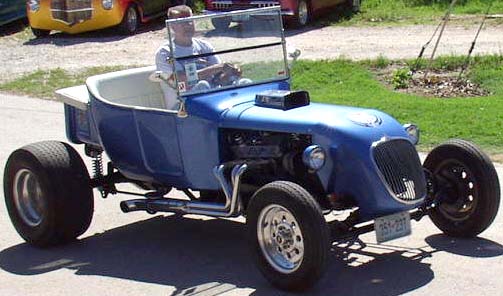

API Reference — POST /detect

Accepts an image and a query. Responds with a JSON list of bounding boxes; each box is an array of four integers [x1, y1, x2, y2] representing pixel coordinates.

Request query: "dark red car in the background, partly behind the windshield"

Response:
[[205, 0, 360, 29]]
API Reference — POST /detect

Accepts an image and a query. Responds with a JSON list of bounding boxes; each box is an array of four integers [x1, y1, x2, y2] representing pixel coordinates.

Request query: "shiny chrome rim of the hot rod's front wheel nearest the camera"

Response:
[[257, 204, 304, 274]]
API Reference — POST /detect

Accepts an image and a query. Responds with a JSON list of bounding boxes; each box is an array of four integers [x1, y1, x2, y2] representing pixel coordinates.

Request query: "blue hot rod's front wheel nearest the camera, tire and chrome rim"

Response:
[[246, 181, 329, 291]]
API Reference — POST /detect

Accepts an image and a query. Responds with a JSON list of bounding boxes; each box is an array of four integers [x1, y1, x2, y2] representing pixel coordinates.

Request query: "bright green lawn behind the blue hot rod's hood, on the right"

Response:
[[293, 56, 503, 153]]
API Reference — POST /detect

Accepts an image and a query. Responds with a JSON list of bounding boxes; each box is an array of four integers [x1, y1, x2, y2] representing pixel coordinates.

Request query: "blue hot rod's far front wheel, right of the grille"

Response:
[[424, 140, 500, 237]]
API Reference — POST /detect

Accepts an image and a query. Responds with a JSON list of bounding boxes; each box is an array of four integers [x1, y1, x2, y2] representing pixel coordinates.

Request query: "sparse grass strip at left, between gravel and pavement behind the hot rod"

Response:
[[0, 66, 130, 99]]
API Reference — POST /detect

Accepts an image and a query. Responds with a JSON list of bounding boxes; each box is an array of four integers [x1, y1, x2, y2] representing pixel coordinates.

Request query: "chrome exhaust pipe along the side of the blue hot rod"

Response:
[[120, 164, 248, 217]]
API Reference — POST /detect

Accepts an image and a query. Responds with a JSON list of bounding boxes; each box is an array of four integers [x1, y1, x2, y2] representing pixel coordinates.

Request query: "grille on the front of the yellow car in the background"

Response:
[[51, 0, 93, 26]]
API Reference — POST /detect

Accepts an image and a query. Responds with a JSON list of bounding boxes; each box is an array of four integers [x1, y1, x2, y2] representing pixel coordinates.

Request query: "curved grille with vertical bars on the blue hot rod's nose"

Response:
[[373, 139, 426, 202]]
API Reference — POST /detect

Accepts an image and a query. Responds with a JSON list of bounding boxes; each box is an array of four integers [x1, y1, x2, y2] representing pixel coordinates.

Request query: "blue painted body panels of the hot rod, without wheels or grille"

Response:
[[65, 71, 426, 220]]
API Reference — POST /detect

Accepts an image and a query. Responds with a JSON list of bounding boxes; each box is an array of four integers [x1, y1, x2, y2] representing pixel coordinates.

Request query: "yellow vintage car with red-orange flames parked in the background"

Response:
[[27, 0, 178, 37]]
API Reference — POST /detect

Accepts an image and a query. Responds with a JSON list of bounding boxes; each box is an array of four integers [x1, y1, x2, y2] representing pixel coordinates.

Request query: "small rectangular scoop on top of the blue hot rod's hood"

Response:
[[255, 90, 310, 110]]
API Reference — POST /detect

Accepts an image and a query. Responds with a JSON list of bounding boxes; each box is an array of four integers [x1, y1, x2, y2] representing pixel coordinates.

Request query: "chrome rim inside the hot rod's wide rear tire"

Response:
[[13, 169, 44, 227]]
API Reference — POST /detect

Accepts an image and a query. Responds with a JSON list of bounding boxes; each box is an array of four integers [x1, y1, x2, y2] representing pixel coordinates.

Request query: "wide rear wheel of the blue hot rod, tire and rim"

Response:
[[4, 141, 94, 247]]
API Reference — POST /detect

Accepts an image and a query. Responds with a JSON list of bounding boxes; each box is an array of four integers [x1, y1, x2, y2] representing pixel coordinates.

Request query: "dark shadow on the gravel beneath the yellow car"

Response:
[[23, 18, 165, 46]]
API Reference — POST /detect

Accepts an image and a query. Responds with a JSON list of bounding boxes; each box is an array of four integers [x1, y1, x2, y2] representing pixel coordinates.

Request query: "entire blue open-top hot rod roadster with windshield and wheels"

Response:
[[4, 8, 500, 290]]
